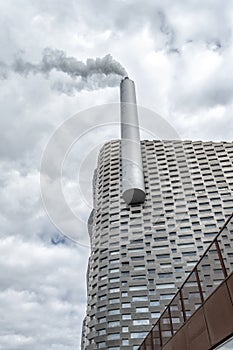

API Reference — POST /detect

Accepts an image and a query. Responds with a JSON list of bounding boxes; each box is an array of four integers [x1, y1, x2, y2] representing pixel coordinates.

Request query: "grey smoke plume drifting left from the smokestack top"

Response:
[[0, 48, 127, 95]]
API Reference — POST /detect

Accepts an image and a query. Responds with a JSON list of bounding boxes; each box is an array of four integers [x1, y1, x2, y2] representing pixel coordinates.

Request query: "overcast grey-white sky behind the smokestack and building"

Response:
[[0, 0, 233, 350]]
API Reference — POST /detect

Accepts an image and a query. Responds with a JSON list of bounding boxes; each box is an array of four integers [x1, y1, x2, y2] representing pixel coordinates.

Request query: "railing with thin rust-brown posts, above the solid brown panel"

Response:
[[139, 213, 233, 350]]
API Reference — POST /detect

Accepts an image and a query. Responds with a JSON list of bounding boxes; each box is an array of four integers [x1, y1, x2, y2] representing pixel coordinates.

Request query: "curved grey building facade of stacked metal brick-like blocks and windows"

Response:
[[82, 140, 233, 350]]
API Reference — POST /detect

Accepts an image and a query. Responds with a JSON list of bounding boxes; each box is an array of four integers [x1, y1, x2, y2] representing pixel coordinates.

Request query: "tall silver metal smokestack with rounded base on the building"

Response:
[[120, 77, 146, 204]]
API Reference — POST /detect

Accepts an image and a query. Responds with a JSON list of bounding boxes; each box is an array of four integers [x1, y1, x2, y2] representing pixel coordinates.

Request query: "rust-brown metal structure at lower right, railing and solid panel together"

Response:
[[139, 213, 233, 350]]
